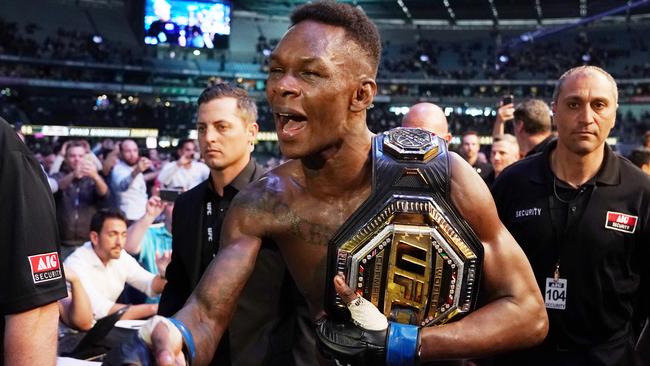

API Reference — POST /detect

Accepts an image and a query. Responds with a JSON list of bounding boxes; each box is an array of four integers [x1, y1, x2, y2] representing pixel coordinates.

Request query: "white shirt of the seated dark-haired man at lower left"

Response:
[[64, 241, 156, 319]]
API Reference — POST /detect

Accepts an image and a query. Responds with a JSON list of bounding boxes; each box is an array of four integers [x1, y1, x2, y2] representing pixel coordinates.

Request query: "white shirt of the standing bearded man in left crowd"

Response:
[[111, 160, 147, 220]]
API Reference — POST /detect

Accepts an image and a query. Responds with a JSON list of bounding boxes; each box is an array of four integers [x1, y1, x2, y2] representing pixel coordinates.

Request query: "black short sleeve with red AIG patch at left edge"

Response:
[[0, 118, 67, 360]]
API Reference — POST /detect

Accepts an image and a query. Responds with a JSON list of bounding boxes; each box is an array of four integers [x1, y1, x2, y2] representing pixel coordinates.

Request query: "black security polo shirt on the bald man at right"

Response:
[[492, 141, 650, 365]]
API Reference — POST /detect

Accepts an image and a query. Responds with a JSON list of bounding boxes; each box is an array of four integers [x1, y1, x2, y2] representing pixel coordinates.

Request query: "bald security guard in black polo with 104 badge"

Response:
[[493, 66, 650, 366]]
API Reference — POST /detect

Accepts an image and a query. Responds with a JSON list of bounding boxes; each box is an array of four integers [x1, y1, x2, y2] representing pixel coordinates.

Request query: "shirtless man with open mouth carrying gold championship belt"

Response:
[[137, 2, 547, 365]]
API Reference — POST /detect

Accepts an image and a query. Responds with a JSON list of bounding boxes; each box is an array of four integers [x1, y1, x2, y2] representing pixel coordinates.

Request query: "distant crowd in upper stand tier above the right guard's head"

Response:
[[379, 28, 650, 80]]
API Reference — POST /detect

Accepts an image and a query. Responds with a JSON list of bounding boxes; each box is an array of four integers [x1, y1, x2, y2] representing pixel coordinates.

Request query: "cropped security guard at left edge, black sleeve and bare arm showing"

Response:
[[0, 118, 67, 365]]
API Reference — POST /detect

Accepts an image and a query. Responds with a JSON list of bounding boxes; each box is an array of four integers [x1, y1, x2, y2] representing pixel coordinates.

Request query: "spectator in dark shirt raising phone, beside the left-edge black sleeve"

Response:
[[53, 140, 108, 259]]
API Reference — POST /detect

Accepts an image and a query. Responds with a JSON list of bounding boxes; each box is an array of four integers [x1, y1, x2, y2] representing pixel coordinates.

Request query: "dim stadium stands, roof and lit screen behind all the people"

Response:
[[0, 0, 650, 165]]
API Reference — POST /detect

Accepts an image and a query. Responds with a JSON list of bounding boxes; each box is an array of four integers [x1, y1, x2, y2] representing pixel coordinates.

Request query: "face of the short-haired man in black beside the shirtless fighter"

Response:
[[196, 97, 258, 170]]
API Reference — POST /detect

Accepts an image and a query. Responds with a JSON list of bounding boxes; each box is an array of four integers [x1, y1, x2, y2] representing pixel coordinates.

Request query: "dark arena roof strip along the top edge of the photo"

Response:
[[232, 0, 650, 24]]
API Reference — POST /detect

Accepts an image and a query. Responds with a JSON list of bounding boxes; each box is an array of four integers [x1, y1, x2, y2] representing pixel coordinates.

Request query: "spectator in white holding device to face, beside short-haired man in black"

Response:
[[158, 140, 210, 190]]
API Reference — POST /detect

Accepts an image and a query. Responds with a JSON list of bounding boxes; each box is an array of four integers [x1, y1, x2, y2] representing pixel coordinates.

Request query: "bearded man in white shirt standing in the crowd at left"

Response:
[[111, 140, 151, 222]]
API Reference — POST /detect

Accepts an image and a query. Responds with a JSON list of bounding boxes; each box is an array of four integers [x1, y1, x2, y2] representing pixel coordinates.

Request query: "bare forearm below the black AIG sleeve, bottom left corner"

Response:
[[4, 301, 59, 366]]
